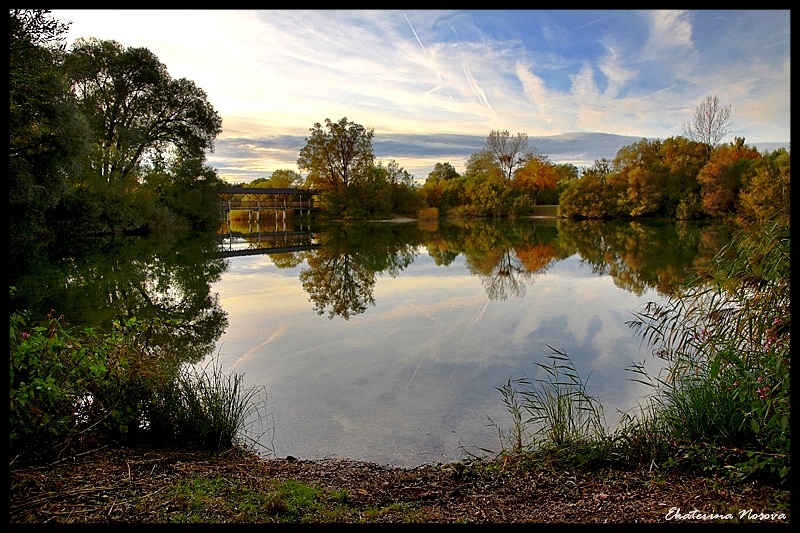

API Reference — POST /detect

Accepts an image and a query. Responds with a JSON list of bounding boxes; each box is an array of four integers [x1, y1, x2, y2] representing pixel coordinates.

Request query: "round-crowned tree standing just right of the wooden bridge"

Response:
[[297, 117, 375, 193]]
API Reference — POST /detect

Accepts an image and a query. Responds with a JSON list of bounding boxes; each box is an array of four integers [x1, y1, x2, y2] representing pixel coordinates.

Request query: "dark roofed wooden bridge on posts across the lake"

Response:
[[219, 187, 320, 222]]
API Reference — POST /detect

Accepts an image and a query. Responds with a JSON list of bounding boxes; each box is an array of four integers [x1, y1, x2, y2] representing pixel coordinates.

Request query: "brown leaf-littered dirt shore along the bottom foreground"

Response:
[[10, 448, 790, 524]]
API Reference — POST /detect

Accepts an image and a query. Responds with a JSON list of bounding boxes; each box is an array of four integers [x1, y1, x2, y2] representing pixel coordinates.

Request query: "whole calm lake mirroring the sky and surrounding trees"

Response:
[[7, 215, 730, 467]]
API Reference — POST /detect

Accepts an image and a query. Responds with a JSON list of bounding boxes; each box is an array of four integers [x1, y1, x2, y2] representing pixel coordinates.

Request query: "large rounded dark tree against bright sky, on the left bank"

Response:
[[66, 39, 222, 182]]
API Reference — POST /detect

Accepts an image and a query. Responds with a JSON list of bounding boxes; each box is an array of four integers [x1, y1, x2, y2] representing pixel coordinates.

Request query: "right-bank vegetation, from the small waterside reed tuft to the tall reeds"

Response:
[[500, 217, 791, 487]]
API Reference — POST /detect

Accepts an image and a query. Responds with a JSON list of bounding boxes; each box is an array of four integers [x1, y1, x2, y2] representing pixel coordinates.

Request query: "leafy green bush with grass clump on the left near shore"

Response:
[[9, 312, 272, 462]]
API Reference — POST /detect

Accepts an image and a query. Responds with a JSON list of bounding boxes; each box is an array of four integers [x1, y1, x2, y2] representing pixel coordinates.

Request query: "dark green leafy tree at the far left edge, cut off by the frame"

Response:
[[9, 9, 88, 244]]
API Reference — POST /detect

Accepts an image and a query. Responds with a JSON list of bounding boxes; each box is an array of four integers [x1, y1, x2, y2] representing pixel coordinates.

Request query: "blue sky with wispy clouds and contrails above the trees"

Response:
[[51, 10, 791, 182]]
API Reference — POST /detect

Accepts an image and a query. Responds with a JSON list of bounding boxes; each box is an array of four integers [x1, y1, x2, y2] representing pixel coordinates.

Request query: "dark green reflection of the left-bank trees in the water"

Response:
[[10, 233, 228, 362]]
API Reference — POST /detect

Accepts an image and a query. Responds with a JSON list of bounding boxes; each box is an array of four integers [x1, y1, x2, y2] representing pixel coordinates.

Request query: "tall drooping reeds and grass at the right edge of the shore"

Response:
[[630, 218, 791, 481]]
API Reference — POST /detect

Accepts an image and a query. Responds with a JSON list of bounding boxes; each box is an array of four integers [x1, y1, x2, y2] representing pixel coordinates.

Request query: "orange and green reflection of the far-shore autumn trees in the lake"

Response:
[[227, 216, 730, 320]]
